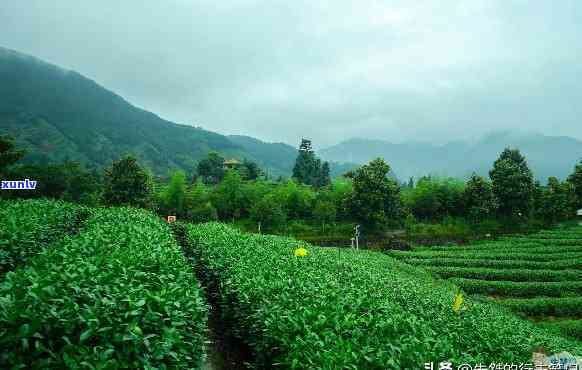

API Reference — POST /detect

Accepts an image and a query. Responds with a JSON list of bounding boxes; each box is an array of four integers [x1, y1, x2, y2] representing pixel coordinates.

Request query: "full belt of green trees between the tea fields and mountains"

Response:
[[0, 137, 582, 234]]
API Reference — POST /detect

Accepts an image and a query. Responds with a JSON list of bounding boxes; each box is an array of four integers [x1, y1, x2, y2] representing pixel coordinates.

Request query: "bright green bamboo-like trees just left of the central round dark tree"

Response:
[[155, 170, 350, 230]]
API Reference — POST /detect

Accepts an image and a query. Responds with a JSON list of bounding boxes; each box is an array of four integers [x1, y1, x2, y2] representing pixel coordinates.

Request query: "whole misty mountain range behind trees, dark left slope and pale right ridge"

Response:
[[0, 47, 582, 182]]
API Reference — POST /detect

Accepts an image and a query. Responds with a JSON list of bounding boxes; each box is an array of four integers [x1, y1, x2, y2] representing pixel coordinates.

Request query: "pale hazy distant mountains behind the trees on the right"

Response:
[[319, 132, 582, 182]]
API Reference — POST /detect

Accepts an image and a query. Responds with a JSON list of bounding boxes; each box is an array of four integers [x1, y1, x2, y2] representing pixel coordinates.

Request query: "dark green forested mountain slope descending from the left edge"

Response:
[[0, 48, 290, 176]]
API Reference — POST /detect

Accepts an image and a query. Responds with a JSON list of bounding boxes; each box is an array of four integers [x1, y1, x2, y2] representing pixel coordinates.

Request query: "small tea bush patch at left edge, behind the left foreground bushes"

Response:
[[0, 199, 88, 277]]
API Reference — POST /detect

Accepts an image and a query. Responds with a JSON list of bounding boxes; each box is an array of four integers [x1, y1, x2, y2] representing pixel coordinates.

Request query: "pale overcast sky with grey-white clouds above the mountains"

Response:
[[0, 0, 582, 147]]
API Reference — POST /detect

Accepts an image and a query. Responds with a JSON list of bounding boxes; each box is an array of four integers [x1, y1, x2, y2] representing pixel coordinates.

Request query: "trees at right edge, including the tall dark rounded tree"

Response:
[[404, 148, 582, 227]]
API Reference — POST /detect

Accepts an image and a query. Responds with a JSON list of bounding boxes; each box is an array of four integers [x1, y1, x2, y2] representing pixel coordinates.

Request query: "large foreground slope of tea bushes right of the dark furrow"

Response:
[[185, 223, 582, 369]]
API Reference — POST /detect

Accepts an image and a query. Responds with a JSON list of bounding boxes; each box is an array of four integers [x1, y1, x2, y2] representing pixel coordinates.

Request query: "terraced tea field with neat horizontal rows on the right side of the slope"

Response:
[[389, 227, 582, 339]]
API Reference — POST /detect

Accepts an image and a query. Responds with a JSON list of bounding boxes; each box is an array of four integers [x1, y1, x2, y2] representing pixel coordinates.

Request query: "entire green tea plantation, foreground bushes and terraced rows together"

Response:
[[0, 201, 582, 369]]
